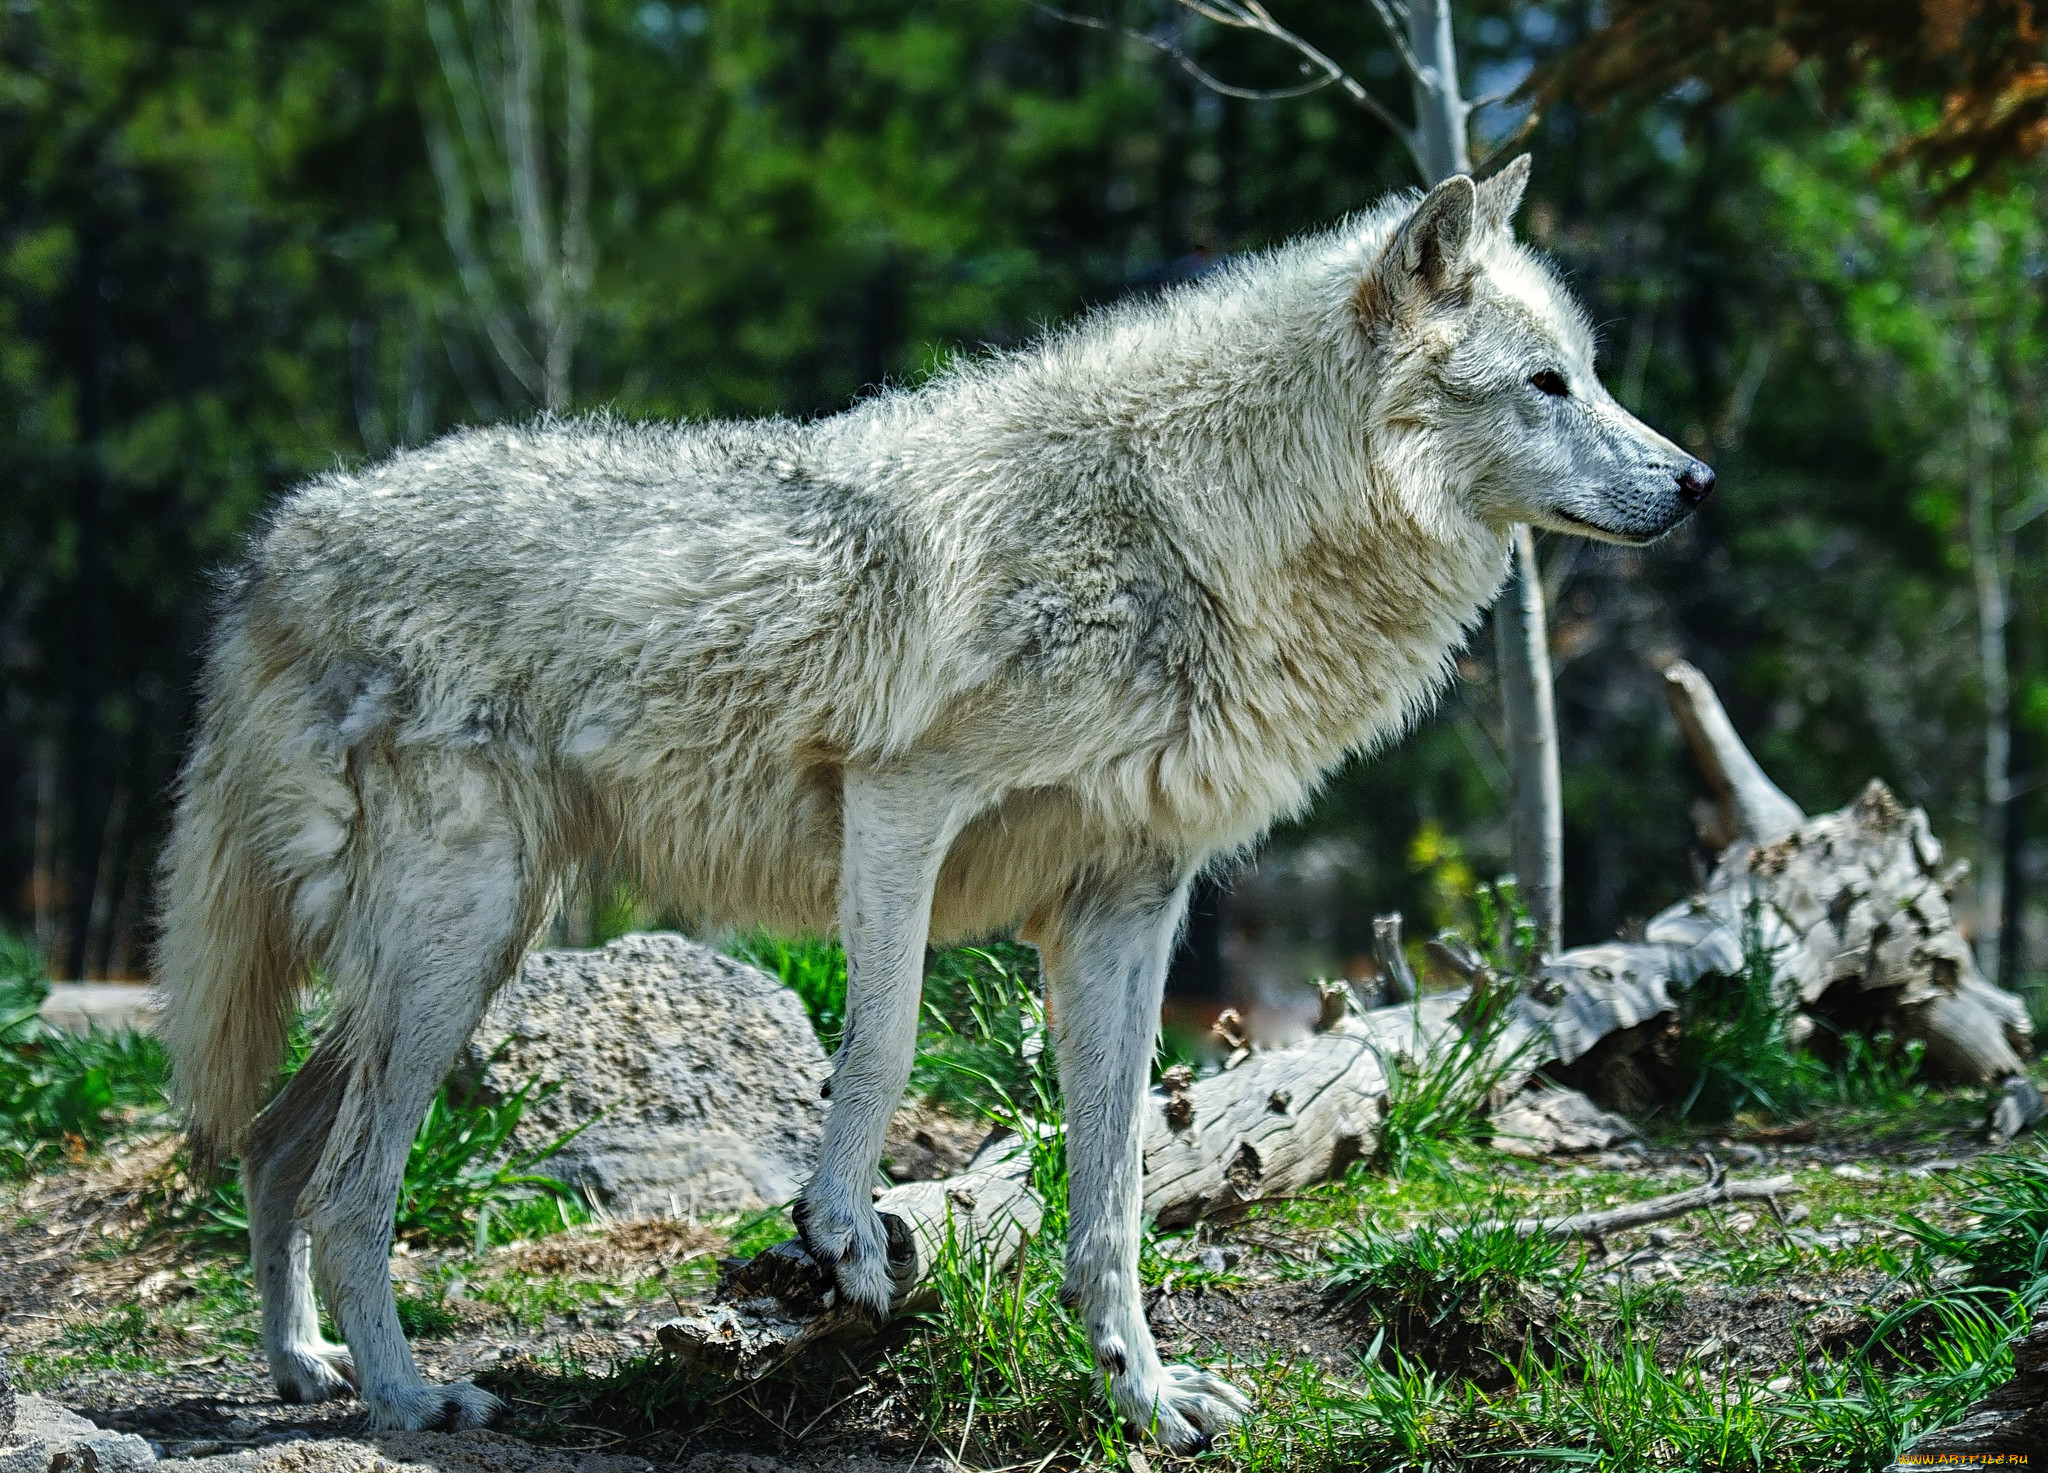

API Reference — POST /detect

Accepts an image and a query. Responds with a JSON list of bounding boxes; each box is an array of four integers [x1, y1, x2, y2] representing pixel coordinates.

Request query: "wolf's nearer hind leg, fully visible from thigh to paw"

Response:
[[301, 770, 532, 1430]]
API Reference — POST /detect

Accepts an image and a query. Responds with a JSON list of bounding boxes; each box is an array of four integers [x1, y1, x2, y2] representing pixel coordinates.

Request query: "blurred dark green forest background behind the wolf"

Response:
[[0, 0, 2048, 1020]]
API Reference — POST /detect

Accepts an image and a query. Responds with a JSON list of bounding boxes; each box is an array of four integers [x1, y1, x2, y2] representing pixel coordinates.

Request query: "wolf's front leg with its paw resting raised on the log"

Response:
[[795, 772, 975, 1323]]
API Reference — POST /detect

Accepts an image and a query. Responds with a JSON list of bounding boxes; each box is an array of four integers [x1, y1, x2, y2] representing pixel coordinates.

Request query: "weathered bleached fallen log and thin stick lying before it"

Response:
[[662, 664, 2042, 1377]]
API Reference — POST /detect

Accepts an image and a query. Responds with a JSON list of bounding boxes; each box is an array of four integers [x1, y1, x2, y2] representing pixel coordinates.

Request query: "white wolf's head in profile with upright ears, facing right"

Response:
[[1358, 154, 1714, 543]]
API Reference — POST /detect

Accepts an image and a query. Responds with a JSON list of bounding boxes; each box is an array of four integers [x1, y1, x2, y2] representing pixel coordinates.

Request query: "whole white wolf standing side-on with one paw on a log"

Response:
[[160, 160, 1712, 1448]]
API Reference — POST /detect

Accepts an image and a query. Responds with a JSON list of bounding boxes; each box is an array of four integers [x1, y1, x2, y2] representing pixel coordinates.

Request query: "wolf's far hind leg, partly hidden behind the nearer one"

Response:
[[242, 1035, 354, 1401]]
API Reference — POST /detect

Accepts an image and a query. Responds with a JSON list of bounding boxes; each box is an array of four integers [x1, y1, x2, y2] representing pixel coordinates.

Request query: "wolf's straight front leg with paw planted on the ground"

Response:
[[1040, 875, 1249, 1453]]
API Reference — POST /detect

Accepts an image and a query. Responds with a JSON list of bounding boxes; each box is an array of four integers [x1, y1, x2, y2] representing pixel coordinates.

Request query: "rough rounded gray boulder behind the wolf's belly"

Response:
[[469, 934, 829, 1217]]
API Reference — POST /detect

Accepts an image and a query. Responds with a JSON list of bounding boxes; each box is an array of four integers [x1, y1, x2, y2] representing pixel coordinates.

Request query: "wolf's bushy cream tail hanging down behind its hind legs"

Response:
[[156, 692, 305, 1168]]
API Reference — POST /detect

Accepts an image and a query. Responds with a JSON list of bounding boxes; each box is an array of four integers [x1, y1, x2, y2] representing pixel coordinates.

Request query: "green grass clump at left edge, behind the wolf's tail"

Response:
[[0, 932, 170, 1176]]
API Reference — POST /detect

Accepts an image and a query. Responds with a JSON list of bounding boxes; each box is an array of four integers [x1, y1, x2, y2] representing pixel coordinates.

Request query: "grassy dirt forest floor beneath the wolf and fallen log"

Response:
[[0, 1092, 2040, 1473]]
